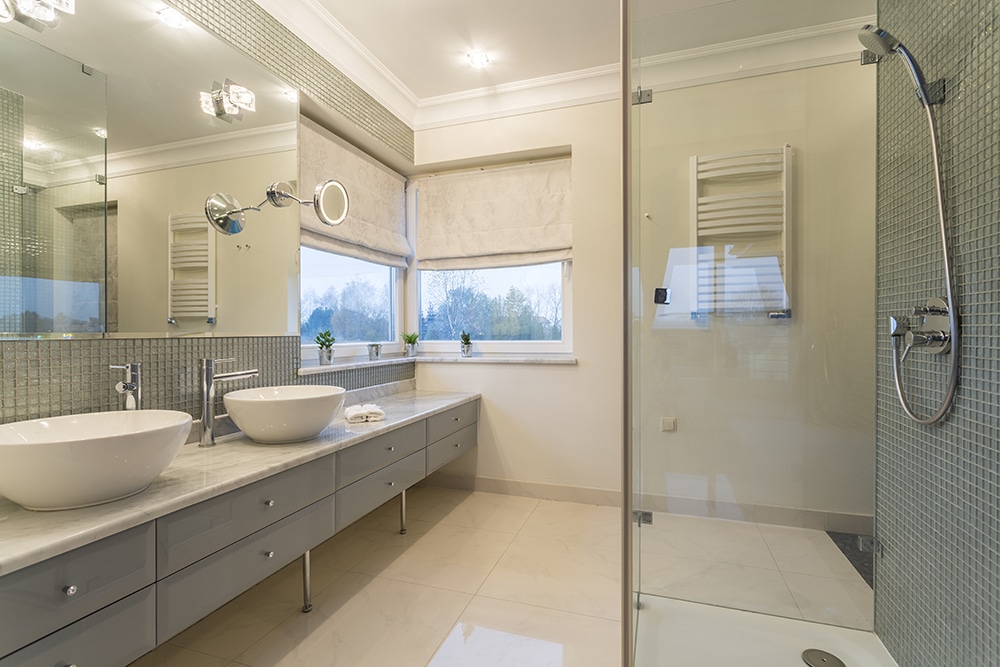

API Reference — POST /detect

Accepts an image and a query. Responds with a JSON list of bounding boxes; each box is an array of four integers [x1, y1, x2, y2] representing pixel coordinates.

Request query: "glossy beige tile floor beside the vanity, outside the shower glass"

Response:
[[133, 487, 621, 667]]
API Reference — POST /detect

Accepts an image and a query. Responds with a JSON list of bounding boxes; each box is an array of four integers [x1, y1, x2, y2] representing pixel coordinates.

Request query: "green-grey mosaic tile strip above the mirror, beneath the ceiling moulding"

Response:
[[168, 0, 413, 162]]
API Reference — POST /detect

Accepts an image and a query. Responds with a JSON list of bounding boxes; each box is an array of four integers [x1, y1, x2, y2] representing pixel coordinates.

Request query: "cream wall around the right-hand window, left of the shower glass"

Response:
[[416, 102, 622, 503]]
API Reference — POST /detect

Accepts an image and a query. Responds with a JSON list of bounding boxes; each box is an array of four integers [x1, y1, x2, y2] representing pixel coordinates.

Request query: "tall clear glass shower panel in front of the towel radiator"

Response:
[[623, 0, 876, 665]]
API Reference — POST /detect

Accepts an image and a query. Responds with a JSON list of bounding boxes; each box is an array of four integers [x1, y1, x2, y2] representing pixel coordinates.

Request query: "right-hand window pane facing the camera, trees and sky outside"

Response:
[[419, 262, 569, 349]]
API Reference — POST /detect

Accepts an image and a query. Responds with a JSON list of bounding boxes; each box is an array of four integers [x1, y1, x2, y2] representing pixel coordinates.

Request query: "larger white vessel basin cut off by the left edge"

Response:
[[0, 410, 191, 510]]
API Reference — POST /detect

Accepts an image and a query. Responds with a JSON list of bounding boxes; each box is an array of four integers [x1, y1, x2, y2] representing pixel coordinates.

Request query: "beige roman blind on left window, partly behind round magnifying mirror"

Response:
[[299, 116, 411, 268]]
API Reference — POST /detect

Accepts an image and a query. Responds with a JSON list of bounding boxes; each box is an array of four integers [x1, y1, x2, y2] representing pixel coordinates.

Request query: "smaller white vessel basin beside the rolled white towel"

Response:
[[222, 385, 347, 445]]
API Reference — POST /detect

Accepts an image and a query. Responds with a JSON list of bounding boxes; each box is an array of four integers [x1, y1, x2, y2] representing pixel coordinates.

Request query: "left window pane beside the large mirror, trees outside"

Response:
[[299, 246, 399, 345]]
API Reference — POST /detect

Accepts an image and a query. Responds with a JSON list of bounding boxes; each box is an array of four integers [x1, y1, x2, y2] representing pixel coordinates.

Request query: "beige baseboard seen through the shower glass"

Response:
[[640, 494, 875, 535]]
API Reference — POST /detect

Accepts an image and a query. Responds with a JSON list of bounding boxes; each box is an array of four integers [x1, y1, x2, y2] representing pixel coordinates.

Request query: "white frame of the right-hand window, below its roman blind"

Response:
[[407, 260, 573, 356]]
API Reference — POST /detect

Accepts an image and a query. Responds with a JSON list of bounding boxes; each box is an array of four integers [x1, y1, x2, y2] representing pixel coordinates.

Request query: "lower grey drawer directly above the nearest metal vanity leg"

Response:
[[156, 495, 334, 644]]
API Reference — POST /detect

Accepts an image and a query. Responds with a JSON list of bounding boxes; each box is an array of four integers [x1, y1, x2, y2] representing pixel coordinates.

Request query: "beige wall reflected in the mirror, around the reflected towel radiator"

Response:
[[108, 151, 299, 335]]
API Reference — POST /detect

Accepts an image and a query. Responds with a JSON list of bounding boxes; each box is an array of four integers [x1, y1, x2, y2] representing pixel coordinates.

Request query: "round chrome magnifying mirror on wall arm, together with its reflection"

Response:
[[205, 179, 350, 236]]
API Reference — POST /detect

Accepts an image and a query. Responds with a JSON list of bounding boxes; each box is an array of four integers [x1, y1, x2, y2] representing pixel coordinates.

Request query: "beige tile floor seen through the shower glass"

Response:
[[640, 512, 874, 630]]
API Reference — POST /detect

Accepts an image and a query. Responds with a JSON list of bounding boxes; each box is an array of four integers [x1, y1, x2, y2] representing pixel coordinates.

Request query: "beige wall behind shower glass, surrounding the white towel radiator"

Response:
[[636, 63, 875, 523]]
